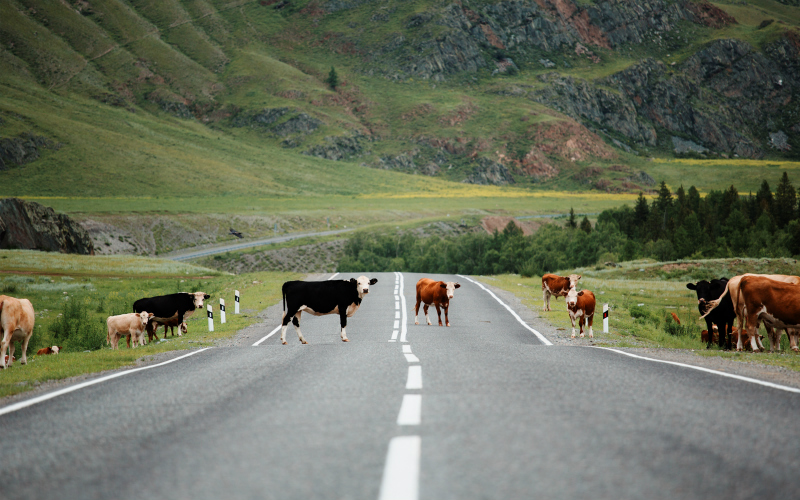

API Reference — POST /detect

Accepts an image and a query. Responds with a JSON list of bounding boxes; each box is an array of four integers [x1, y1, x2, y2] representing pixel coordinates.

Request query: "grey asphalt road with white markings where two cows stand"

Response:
[[0, 273, 800, 500]]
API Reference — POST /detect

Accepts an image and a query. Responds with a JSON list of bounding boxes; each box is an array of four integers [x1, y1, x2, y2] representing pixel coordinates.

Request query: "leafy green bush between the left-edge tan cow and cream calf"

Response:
[[49, 300, 107, 352]]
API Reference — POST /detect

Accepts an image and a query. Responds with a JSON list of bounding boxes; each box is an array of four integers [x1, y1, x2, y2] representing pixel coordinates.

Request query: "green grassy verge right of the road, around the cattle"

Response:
[[479, 259, 800, 371]]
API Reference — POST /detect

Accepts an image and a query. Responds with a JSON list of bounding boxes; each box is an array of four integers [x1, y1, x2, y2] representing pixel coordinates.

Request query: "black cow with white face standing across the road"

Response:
[[281, 276, 378, 344]]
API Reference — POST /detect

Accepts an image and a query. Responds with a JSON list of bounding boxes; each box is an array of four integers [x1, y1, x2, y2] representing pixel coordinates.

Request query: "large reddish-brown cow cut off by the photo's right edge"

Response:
[[736, 276, 800, 352]]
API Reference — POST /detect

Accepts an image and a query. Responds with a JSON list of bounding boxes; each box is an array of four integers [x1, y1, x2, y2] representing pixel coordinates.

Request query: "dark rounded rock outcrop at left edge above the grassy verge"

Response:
[[0, 198, 94, 255]]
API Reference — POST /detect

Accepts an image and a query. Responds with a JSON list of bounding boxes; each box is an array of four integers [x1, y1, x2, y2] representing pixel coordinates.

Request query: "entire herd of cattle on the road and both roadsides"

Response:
[[0, 274, 800, 369]]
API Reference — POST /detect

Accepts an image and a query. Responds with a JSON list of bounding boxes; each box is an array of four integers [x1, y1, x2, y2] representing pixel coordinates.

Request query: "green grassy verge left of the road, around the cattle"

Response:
[[0, 251, 300, 397]]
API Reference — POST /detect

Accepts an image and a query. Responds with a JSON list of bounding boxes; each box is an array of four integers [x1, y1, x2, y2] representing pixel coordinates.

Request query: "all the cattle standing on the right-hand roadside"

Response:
[[542, 274, 800, 352]]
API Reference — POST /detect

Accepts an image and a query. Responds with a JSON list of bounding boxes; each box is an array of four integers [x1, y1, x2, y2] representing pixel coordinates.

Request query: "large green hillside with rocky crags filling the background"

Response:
[[0, 0, 800, 195]]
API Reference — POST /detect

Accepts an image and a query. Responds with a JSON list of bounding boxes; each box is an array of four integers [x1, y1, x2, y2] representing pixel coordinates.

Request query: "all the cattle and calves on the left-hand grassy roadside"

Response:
[[0, 292, 210, 369]]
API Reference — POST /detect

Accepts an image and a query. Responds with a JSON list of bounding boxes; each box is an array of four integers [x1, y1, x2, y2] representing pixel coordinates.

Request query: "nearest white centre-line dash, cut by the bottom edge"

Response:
[[378, 436, 422, 500]]
